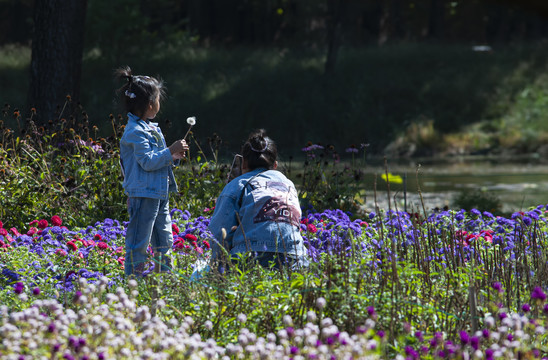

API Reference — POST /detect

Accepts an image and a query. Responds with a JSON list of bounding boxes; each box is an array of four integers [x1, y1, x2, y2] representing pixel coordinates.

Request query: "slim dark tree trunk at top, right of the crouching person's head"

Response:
[[324, 0, 347, 75]]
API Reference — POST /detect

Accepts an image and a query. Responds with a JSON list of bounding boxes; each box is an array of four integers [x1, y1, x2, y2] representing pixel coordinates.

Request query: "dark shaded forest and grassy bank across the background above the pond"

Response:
[[0, 0, 548, 156]]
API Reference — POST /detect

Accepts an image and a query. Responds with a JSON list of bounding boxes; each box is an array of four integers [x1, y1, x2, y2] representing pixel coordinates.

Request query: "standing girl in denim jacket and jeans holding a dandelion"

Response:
[[115, 67, 188, 276]]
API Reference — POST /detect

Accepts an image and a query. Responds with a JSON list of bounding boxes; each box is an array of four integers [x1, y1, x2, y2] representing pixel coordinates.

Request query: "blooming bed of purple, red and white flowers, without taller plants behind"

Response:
[[0, 206, 548, 359]]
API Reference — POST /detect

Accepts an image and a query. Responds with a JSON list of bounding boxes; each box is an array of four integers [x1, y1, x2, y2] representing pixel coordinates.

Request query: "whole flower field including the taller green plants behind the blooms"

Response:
[[0, 111, 548, 360]]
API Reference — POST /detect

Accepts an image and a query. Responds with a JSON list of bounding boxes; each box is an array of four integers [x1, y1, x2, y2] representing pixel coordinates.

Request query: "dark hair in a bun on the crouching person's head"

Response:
[[242, 129, 278, 170]]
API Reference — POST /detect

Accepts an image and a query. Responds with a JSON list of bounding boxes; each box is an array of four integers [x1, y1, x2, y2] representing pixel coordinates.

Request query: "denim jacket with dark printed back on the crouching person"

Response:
[[209, 169, 306, 259]]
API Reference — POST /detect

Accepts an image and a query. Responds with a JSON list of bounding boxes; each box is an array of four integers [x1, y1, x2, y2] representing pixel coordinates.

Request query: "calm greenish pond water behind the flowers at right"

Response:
[[362, 157, 548, 213]]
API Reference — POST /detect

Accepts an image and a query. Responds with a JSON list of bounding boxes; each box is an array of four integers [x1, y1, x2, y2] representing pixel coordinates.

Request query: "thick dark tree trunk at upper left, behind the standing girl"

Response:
[[28, 0, 87, 123]]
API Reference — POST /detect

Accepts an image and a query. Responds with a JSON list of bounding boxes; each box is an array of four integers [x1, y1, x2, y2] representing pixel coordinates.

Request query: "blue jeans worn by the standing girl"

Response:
[[124, 197, 173, 276]]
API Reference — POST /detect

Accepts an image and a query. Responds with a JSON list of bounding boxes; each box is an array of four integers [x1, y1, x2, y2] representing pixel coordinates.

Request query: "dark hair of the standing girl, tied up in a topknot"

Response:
[[114, 66, 165, 116]]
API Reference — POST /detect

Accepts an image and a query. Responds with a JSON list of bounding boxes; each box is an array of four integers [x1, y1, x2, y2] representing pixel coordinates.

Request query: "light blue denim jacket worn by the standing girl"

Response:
[[120, 113, 179, 200]]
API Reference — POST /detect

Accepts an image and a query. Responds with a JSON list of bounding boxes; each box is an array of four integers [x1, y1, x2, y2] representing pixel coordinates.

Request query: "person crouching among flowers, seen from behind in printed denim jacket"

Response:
[[209, 129, 308, 271]]
